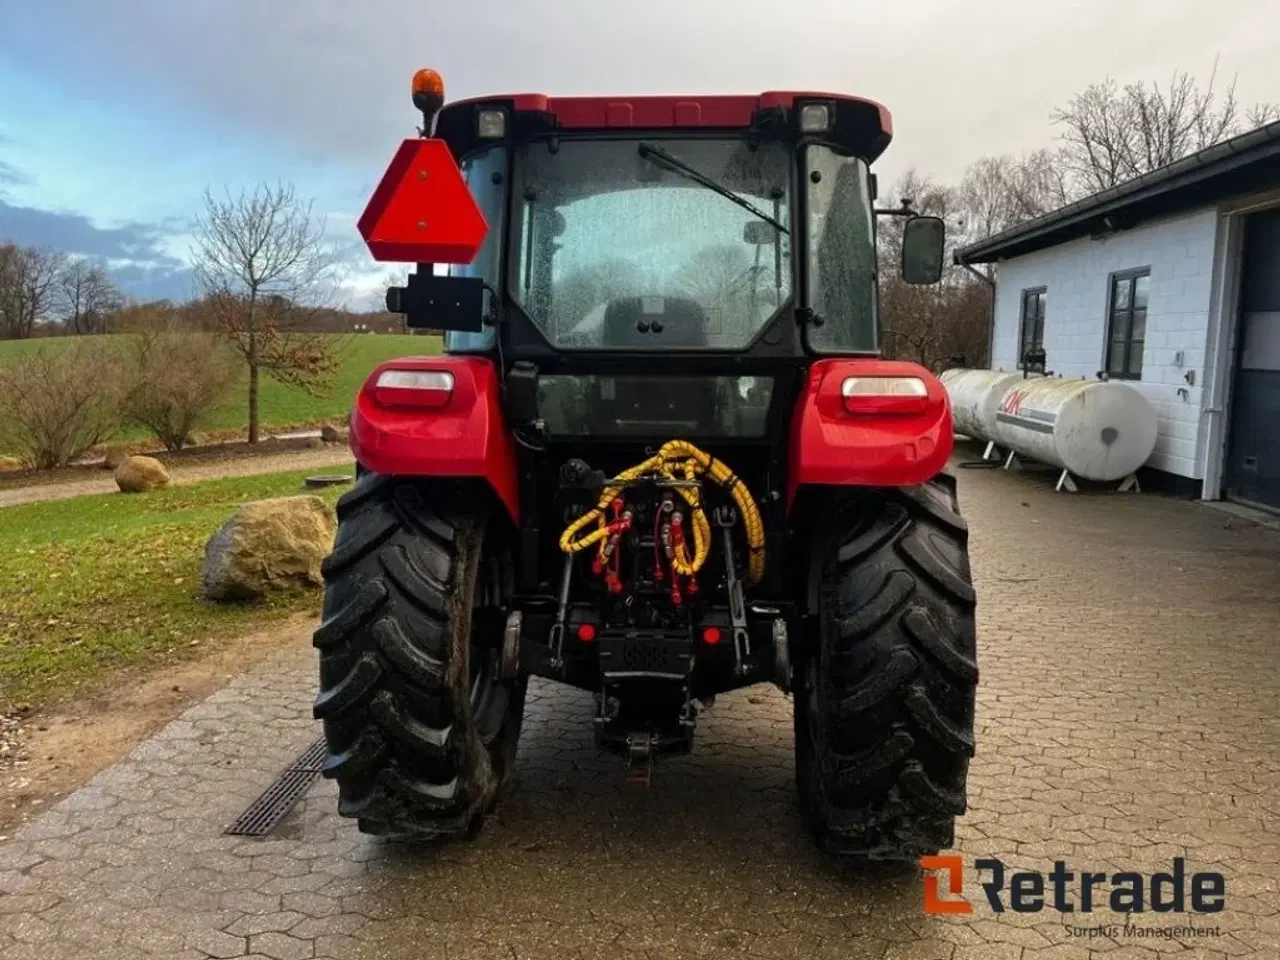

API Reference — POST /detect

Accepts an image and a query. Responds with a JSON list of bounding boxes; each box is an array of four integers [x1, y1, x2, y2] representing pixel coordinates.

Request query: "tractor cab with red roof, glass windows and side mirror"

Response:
[[366, 78, 942, 442]]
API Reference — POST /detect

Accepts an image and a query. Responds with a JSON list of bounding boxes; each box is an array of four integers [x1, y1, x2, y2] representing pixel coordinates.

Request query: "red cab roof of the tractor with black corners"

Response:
[[435, 91, 893, 163]]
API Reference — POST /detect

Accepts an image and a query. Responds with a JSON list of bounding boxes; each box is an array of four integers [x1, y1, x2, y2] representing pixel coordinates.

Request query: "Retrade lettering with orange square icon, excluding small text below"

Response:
[[920, 856, 1226, 914]]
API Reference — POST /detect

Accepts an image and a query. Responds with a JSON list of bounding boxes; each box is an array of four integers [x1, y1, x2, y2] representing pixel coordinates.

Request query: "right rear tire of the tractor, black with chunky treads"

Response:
[[794, 474, 978, 861]]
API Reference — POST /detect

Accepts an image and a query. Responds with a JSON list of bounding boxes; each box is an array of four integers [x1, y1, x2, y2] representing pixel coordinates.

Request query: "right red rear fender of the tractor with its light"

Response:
[[787, 360, 955, 508]]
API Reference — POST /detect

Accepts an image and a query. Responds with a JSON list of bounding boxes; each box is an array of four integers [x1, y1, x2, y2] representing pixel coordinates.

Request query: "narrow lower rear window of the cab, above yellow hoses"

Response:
[[538, 374, 773, 439]]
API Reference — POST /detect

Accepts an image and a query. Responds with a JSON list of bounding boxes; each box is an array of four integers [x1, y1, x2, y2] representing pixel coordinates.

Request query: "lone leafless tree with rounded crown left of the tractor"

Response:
[[195, 184, 338, 443]]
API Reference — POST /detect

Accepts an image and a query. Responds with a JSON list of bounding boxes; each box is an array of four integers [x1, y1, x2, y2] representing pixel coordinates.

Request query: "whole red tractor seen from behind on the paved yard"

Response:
[[315, 70, 978, 860]]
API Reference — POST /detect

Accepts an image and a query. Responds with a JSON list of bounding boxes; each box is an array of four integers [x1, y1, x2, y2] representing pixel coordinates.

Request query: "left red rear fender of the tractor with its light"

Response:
[[351, 356, 520, 525]]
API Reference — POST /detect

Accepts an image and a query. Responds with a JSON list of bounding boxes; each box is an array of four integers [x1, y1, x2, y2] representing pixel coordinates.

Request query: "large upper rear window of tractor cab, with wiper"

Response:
[[508, 138, 792, 349]]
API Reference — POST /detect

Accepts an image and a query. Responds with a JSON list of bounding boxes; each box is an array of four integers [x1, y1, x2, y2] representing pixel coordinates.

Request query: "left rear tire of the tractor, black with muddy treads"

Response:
[[314, 474, 527, 840]]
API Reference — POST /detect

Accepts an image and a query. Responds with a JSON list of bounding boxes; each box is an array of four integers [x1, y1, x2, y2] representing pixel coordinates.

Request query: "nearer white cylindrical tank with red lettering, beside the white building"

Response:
[[993, 378, 1156, 481]]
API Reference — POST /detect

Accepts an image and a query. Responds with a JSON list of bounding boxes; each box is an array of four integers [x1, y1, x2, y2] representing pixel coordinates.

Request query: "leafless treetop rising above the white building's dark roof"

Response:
[[1051, 64, 1280, 193]]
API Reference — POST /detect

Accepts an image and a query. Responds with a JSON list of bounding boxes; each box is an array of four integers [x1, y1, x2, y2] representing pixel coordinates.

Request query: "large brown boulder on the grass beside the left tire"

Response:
[[201, 495, 338, 600]]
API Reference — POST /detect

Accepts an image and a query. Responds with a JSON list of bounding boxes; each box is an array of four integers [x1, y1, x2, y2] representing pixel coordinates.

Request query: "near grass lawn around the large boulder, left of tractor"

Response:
[[0, 470, 349, 713]]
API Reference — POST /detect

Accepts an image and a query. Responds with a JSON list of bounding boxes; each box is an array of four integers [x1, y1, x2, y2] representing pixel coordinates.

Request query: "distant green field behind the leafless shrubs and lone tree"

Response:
[[0, 334, 440, 453]]
